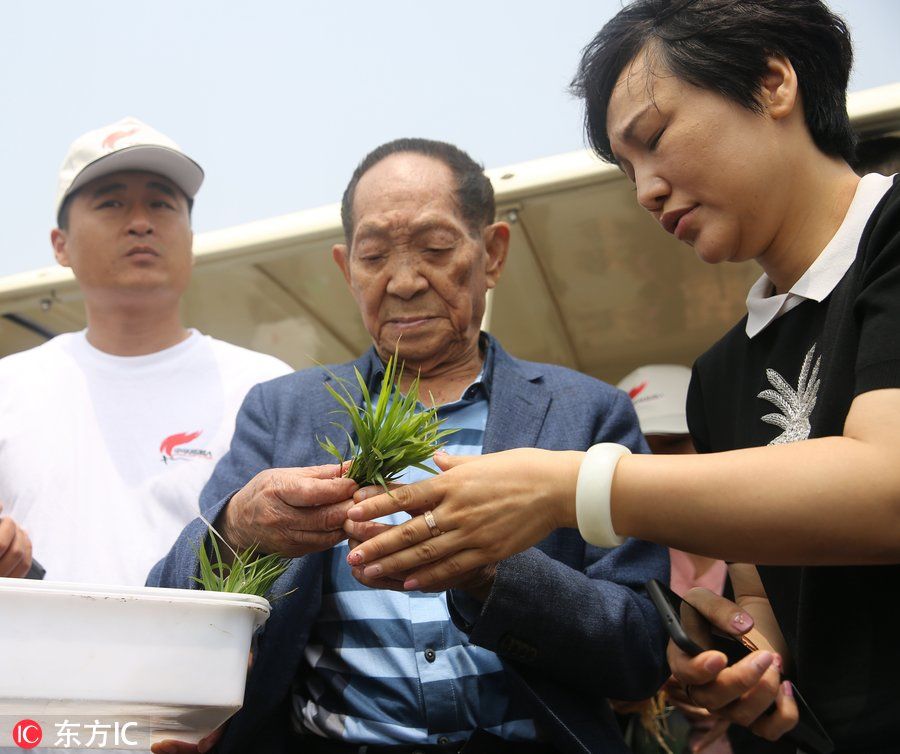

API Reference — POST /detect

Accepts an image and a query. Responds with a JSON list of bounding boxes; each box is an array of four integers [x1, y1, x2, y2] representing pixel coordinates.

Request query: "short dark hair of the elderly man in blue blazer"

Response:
[[341, 139, 495, 245]]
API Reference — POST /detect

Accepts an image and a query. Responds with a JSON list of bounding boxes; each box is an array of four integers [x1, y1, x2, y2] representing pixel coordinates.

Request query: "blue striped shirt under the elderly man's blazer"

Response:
[[293, 349, 536, 745]]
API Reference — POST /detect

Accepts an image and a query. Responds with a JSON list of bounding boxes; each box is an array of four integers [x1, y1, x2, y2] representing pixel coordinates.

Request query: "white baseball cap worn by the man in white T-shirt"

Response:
[[56, 117, 203, 219]]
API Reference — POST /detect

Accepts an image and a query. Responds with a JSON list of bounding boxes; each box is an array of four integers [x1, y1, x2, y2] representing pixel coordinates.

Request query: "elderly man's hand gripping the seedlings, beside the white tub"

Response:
[[216, 464, 359, 558]]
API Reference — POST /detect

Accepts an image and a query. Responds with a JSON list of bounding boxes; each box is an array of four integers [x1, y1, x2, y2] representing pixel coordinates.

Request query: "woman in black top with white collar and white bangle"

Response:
[[348, 0, 900, 752]]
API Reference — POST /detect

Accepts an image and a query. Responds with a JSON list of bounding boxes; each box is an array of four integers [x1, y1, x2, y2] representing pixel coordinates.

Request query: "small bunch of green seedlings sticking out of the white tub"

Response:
[[192, 516, 291, 597]]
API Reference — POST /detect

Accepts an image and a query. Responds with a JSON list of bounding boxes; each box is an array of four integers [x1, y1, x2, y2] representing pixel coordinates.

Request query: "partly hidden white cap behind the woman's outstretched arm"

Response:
[[619, 364, 691, 435]]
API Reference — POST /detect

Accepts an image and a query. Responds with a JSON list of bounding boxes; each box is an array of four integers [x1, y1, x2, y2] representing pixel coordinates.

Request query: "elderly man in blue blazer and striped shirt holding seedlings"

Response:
[[149, 139, 668, 754]]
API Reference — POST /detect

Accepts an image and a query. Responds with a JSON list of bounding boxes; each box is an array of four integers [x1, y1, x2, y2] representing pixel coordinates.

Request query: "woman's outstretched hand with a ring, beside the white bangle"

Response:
[[347, 448, 584, 590]]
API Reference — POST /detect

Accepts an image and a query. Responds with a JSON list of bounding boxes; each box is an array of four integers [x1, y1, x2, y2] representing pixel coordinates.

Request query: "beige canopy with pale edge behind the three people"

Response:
[[0, 83, 900, 382]]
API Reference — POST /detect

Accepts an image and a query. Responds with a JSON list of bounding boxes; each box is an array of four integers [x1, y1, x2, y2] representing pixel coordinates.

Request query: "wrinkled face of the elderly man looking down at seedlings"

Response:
[[334, 153, 509, 371]]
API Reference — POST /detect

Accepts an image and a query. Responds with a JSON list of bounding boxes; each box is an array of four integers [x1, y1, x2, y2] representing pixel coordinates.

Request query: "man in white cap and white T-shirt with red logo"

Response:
[[0, 118, 291, 585]]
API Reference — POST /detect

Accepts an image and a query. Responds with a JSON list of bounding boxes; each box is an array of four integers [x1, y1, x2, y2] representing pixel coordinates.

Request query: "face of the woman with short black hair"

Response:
[[606, 50, 789, 263]]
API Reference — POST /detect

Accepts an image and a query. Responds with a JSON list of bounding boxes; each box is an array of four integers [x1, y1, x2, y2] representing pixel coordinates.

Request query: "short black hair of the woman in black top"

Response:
[[572, 0, 856, 162]]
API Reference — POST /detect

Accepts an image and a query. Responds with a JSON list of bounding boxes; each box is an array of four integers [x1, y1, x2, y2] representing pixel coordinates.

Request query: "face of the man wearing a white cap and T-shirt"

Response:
[[51, 171, 193, 301]]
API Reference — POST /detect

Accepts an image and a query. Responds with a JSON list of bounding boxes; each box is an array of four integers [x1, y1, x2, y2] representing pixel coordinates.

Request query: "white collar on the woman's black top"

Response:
[[746, 173, 894, 338]]
